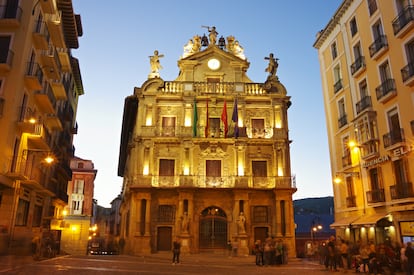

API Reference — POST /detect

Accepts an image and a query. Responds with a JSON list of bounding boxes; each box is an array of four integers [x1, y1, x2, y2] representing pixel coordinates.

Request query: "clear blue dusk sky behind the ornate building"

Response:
[[72, 0, 342, 207]]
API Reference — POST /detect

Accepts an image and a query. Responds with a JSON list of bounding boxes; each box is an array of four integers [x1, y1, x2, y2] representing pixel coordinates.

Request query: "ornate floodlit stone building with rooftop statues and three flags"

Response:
[[118, 28, 296, 256]]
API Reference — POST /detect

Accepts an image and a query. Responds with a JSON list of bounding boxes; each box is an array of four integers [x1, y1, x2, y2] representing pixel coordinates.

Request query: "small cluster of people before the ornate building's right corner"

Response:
[[254, 237, 288, 266]]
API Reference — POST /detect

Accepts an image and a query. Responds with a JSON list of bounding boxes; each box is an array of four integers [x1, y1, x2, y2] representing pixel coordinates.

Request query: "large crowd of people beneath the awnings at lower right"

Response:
[[317, 236, 414, 275]]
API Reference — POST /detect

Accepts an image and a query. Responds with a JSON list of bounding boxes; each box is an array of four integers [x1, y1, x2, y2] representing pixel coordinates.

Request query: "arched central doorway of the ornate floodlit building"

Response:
[[199, 206, 227, 249]]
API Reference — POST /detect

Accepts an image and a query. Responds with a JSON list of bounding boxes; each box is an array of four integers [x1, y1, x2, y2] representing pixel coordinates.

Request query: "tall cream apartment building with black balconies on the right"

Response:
[[314, 0, 414, 246]]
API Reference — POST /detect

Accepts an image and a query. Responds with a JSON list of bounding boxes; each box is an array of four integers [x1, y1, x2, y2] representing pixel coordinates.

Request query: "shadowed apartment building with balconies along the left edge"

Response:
[[0, 0, 83, 255]]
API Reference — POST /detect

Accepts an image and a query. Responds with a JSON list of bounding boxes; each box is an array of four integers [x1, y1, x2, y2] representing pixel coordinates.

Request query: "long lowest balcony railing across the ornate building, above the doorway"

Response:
[[130, 175, 296, 189]]
